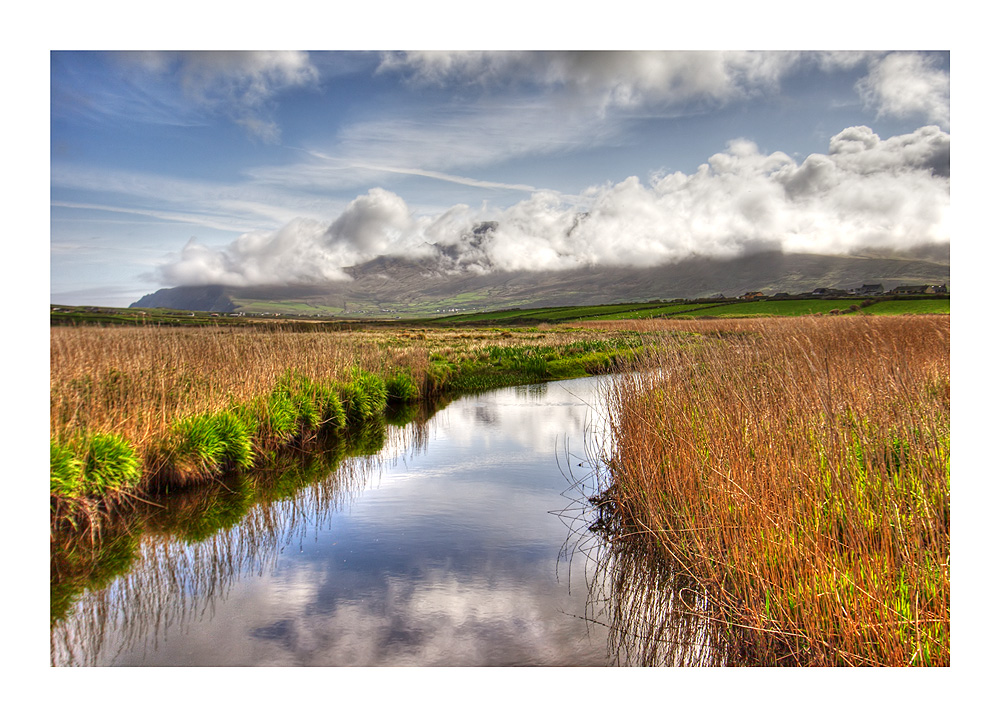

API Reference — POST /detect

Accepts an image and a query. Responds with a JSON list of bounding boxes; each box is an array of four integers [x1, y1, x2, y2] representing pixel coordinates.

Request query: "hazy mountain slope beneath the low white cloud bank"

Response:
[[132, 252, 950, 316]]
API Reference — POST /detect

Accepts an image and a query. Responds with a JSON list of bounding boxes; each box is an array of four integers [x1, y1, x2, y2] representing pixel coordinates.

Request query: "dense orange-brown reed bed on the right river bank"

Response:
[[599, 316, 950, 666]]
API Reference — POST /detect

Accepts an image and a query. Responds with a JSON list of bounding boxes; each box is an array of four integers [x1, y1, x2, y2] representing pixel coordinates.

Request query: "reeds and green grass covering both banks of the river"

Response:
[[50, 313, 950, 665]]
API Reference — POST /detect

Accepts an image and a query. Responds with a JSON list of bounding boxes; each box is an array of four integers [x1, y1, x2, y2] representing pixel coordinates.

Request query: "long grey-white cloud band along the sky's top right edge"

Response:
[[378, 51, 950, 129]]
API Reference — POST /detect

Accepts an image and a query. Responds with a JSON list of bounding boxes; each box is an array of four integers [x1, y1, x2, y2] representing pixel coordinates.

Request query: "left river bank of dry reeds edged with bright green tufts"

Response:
[[50, 325, 639, 521]]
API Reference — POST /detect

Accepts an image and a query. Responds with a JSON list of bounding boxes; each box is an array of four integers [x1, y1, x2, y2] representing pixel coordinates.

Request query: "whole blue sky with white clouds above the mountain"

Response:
[[49, 50, 951, 306]]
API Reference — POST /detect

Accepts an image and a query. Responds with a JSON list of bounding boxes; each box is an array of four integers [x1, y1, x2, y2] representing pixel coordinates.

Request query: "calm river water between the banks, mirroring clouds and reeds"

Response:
[[52, 378, 615, 666]]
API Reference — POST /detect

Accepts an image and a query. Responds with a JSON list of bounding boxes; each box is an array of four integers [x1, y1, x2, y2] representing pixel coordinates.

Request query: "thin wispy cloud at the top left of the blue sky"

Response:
[[122, 51, 319, 142]]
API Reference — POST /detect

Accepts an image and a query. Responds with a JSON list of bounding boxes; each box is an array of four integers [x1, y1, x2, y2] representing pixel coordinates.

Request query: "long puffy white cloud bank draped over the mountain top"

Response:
[[152, 126, 950, 285]]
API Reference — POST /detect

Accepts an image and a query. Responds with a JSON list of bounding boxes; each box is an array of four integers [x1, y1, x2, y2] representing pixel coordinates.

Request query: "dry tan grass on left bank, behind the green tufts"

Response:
[[49, 325, 632, 464]]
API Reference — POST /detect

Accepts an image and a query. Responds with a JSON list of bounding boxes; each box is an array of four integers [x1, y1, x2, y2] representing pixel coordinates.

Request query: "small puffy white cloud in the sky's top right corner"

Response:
[[857, 52, 951, 128]]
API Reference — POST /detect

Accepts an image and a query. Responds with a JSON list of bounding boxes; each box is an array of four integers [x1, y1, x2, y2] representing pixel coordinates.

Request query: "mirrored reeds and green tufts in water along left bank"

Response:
[[50, 411, 430, 665]]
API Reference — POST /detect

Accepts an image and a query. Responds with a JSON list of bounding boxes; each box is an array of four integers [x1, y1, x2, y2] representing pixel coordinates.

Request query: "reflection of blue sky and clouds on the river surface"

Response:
[[74, 379, 609, 666]]
